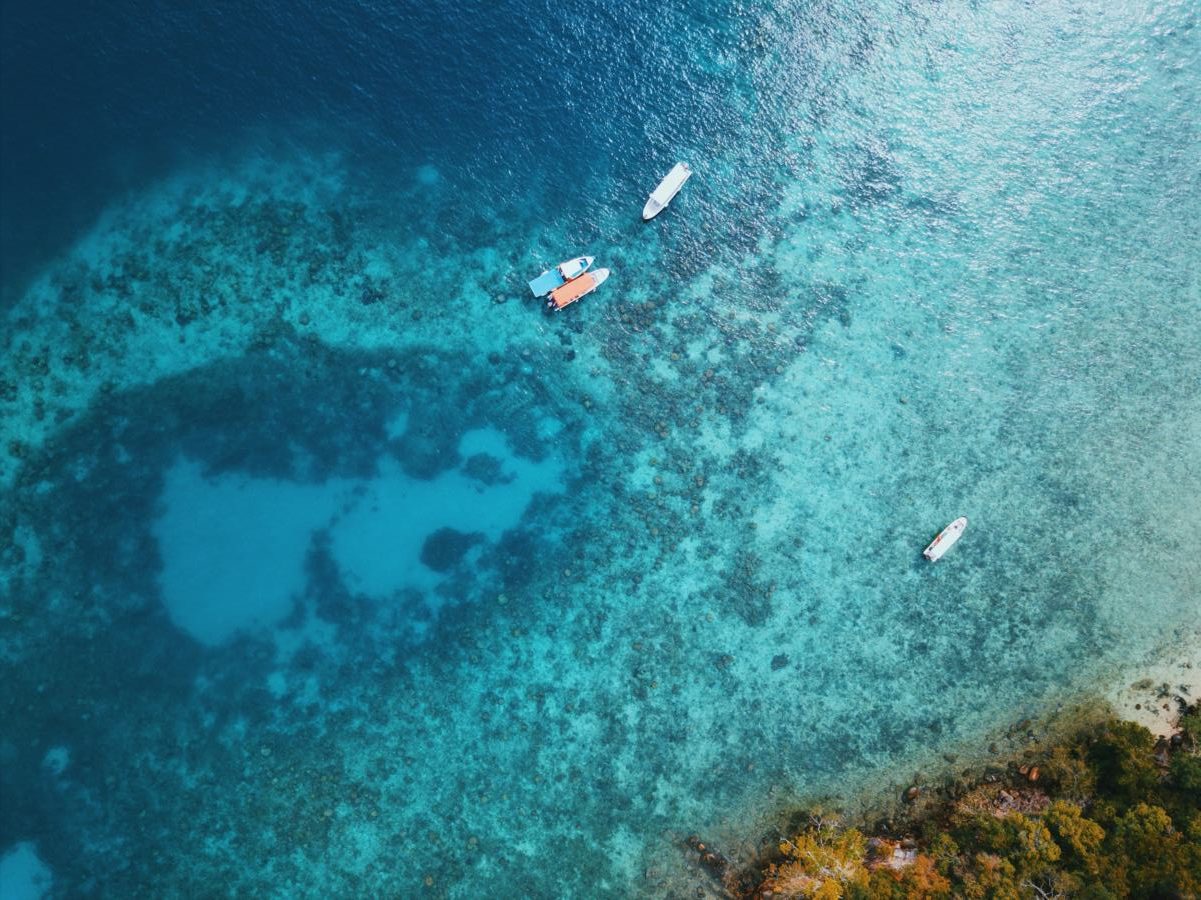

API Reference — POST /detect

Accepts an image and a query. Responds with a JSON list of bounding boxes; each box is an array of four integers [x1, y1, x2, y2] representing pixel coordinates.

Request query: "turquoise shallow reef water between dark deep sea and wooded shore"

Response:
[[0, 2, 1201, 896]]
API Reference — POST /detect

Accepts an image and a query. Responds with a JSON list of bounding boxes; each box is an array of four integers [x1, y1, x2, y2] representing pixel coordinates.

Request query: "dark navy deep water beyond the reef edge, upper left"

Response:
[[0, 2, 770, 296]]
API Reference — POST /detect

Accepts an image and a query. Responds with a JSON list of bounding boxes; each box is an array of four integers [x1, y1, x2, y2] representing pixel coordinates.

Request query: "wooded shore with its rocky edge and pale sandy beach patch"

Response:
[[680, 672, 1201, 900]]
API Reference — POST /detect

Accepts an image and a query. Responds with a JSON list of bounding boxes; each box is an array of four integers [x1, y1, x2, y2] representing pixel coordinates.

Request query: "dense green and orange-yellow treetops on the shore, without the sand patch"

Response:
[[701, 704, 1201, 900]]
